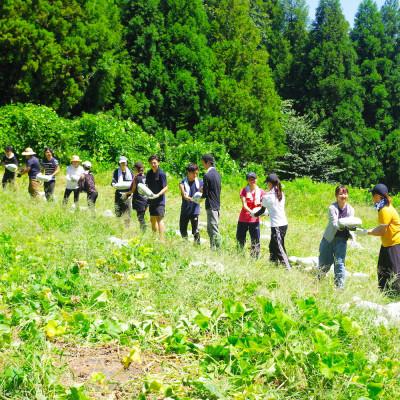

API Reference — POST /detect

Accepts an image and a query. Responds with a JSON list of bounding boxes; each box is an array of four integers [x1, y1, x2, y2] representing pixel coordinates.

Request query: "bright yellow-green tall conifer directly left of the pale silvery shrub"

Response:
[[197, 0, 285, 163]]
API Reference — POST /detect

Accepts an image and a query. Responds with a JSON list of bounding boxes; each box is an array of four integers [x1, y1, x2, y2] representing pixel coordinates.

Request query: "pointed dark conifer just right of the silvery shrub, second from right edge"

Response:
[[304, 0, 383, 185]]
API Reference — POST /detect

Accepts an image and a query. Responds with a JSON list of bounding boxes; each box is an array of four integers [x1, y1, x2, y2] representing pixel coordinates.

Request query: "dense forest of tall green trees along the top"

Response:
[[0, 0, 400, 189]]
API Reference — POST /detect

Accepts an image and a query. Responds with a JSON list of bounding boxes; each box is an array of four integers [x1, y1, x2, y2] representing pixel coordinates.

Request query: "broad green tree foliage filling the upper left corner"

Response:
[[0, 0, 130, 115]]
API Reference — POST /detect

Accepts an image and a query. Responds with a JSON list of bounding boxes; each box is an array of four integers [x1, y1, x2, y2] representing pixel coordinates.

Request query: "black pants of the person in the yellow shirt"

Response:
[[378, 244, 400, 294]]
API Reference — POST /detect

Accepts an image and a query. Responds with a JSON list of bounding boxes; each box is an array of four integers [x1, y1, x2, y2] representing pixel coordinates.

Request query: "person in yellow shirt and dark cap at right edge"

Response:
[[367, 183, 400, 295]]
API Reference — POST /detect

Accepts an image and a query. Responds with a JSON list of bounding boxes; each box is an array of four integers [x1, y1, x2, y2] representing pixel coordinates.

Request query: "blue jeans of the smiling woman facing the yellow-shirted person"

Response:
[[318, 237, 347, 288]]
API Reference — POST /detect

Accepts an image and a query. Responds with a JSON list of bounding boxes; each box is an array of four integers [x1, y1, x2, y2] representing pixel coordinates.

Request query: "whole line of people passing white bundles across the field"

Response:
[[2, 146, 400, 294]]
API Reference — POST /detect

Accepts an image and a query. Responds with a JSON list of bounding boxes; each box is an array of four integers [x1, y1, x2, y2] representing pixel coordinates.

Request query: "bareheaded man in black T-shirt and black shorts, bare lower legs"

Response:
[[146, 154, 168, 239]]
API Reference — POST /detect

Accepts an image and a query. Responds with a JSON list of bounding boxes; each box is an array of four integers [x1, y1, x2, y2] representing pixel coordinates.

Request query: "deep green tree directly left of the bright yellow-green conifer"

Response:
[[122, 0, 216, 132]]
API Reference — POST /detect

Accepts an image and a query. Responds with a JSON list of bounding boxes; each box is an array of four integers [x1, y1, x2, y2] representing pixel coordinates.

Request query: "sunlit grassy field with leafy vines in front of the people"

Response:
[[0, 174, 400, 400]]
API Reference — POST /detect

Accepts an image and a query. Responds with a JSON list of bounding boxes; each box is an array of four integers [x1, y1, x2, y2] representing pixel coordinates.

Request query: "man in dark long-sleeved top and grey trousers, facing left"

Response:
[[201, 154, 221, 250]]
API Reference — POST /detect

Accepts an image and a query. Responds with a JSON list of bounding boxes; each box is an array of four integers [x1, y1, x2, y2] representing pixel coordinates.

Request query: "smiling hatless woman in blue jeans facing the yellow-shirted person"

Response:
[[318, 185, 354, 289]]
